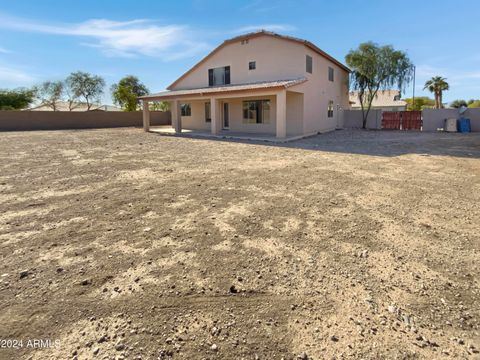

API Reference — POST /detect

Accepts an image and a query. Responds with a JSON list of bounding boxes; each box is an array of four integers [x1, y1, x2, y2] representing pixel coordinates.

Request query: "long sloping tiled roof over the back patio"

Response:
[[139, 77, 307, 100]]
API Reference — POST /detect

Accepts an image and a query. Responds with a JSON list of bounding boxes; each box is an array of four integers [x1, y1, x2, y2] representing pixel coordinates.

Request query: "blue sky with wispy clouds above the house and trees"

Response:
[[0, 0, 480, 103]]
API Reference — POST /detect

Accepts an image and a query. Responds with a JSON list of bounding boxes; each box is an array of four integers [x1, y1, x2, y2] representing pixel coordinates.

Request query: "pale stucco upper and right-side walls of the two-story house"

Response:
[[171, 36, 349, 134]]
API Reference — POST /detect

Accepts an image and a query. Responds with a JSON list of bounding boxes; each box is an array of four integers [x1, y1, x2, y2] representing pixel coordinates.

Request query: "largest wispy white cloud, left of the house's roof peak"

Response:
[[0, 15, 207, 60]]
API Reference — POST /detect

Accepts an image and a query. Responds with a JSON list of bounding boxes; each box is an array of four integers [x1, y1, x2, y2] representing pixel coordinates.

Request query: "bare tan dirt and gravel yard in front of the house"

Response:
[[0, 129, 480, 359]]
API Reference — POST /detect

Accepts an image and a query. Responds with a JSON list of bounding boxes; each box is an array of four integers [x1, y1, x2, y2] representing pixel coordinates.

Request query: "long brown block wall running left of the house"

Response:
[[0, 111, 171, 131]]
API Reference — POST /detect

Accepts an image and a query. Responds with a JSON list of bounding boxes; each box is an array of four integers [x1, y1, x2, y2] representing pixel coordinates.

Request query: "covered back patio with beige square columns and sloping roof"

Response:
[[140, 78, 306, 141]]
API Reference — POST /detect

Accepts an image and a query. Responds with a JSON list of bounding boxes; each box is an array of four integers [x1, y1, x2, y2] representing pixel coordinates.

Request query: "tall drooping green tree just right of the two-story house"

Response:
[[345, 42, 413, 129]]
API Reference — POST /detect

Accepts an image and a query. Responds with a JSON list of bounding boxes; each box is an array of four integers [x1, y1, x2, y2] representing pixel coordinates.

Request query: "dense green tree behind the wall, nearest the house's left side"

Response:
[[111, 75, 148, 111]]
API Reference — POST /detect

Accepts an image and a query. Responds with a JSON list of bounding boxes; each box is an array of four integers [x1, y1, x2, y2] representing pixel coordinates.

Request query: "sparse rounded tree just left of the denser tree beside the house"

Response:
[[66, 71, 105, 110]]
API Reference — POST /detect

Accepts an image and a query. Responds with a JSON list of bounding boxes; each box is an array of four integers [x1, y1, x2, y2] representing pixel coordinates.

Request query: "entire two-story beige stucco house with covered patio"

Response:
[[141, 30, 350, 138]]
